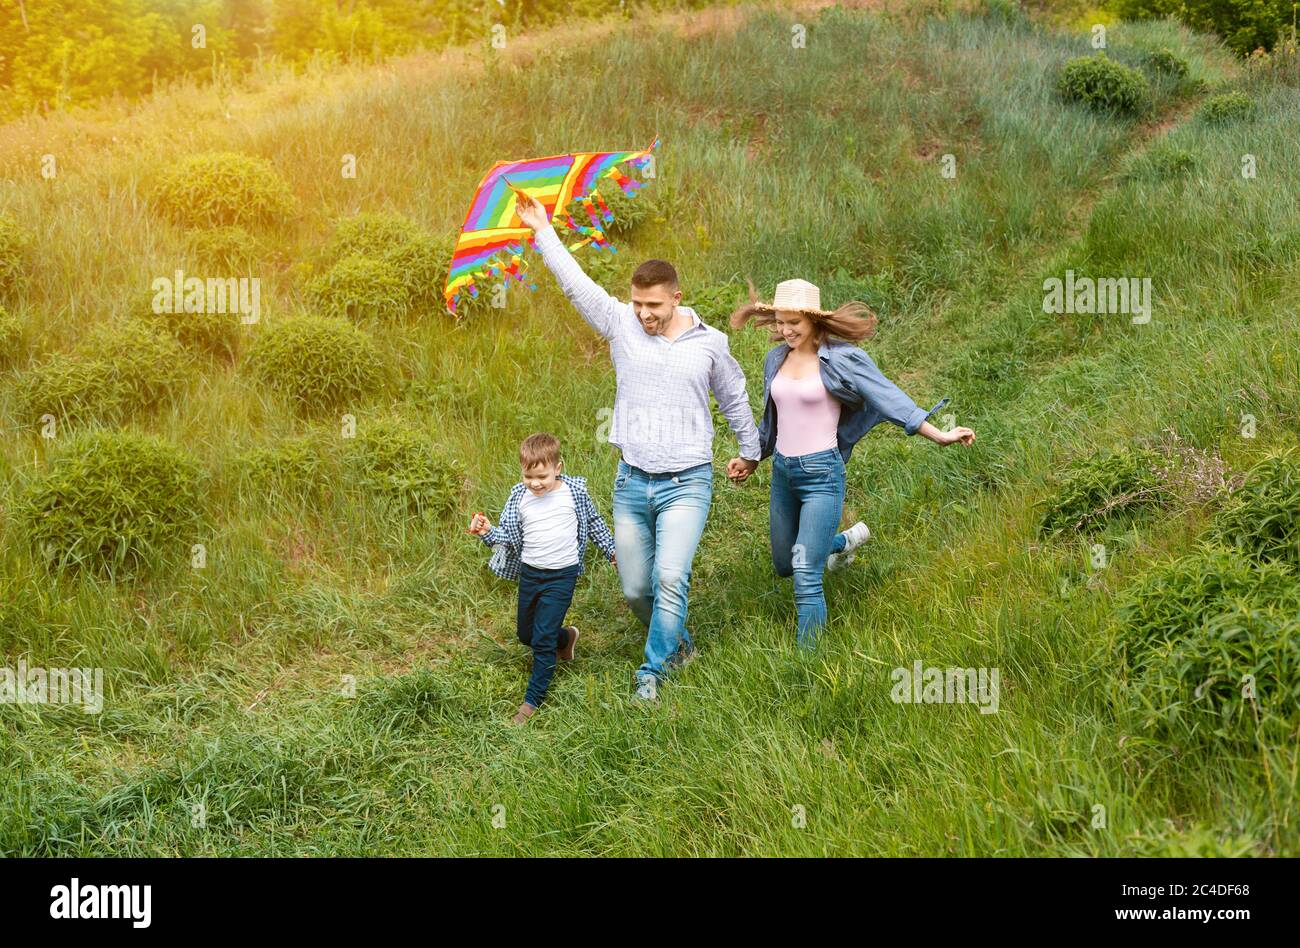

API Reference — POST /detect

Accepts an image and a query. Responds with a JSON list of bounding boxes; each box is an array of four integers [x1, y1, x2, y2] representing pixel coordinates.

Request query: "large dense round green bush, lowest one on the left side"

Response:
[[17, 430, 203, 570]]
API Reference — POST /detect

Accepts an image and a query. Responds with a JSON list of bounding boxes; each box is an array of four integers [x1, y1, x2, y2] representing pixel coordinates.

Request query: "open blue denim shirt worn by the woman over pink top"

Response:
[[758, 339, 948, 464]]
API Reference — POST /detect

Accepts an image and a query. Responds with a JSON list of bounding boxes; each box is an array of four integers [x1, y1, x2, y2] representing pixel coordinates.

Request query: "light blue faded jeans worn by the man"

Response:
[[614, 460, 714, 679]]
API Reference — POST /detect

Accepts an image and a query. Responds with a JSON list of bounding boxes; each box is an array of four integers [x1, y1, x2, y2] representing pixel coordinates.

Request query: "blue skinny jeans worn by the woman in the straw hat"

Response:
[[764, 447, 845, 648]]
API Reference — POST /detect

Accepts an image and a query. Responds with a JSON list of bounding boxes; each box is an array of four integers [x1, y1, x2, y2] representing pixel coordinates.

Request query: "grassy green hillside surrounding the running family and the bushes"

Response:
[[0, 4, 1300, 856]]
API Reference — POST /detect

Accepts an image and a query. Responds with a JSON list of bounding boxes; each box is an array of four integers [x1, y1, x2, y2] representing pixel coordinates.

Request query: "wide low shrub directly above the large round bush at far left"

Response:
[[16, 319, 187, 424]]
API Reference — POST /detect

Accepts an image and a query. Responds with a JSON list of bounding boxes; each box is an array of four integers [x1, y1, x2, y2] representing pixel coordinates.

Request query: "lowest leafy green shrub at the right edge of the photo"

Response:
[[1128, 603, 1300, 744]]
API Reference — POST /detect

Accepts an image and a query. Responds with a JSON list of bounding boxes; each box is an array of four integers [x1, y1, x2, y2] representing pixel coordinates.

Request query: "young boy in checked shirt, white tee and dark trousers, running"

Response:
[[469, 433, 618, 724]]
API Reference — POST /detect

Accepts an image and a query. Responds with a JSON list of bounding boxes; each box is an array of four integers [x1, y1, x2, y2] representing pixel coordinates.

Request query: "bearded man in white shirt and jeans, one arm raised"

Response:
[[519, 196, 759, 701]]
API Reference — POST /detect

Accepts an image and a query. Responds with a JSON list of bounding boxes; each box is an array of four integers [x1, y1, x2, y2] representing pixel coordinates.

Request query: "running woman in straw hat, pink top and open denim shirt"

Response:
[[727, 280, 975, 648]]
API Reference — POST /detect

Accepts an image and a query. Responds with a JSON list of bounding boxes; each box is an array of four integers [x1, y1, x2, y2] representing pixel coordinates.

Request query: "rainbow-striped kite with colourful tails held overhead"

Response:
[[443, 137, 659, 313]]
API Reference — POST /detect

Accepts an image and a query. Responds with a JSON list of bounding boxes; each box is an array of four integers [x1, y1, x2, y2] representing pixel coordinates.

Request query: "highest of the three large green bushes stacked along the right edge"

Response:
[[1209, 447, 1300, 567]]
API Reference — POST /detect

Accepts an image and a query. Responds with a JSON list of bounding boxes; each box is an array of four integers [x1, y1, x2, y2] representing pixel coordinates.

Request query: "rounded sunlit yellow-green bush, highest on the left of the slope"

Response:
[[155, 152, 296, 226]]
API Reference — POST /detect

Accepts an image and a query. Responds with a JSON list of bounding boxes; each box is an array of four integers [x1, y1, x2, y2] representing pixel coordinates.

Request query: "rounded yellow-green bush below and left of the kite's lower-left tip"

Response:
[[248, 316, 384, 414]]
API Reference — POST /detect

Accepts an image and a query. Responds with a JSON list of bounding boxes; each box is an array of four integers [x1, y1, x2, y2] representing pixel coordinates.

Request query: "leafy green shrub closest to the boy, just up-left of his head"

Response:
[[350, 417, 465, 514]]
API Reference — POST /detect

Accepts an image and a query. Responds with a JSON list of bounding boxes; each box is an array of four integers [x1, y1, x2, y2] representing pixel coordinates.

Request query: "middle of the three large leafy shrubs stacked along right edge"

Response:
[[1109, 545, 1300, 670]]
